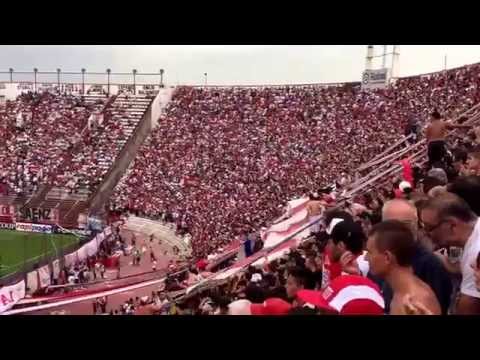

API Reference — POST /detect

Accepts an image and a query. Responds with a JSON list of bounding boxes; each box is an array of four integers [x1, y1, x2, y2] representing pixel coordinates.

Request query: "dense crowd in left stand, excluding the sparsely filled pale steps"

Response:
[[0, 92, 104, 194]]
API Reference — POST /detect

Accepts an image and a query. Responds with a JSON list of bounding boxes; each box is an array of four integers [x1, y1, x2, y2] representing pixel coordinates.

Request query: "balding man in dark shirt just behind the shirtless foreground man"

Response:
[[379, 199, 452, 314]]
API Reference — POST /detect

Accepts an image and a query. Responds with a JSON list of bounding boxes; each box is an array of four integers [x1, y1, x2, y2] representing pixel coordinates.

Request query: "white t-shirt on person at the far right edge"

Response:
[[460, 219, 480, 298]]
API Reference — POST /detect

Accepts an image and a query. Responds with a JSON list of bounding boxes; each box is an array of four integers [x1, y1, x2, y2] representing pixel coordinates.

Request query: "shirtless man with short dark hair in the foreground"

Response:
[[366, 220, 441, 315]]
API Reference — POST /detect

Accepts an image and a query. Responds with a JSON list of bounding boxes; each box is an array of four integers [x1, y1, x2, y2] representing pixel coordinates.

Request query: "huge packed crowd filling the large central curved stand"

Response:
[[111, 64, 480, 256]]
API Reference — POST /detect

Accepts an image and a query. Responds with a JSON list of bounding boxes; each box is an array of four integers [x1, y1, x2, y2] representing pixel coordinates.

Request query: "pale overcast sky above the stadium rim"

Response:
[[0, 45, 480, 85]]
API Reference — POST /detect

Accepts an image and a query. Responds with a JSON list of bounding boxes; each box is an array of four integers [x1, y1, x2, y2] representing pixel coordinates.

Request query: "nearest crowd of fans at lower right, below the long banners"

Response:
[[145, 119, 480, 315]]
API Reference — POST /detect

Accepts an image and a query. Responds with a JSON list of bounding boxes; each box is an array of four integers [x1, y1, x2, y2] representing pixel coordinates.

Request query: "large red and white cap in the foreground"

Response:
[[297, 275, 385, 315]]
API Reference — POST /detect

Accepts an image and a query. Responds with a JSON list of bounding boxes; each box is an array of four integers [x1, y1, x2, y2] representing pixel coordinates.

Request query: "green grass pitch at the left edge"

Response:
[[0, 230, 79, 278]]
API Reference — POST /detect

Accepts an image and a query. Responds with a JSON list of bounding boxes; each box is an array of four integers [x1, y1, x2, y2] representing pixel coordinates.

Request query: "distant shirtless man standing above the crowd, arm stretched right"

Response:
[[425, 111, 471, 167]]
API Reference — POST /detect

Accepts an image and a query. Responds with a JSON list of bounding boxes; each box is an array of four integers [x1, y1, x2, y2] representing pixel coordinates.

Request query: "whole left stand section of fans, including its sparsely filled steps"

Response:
[[0, 91, 151, 194]]
